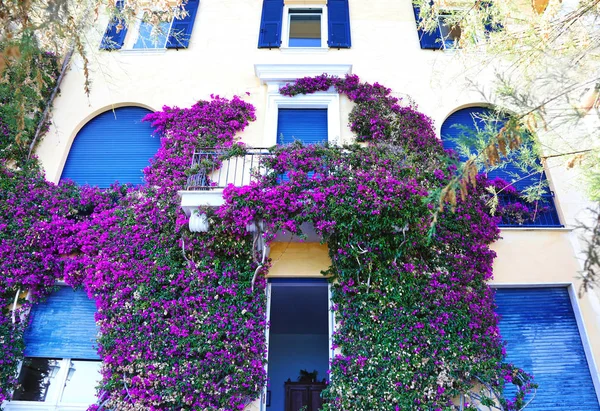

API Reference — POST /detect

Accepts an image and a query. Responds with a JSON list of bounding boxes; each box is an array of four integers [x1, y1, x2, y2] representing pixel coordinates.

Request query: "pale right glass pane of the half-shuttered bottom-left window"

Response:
[[61, 360, 102, 404]]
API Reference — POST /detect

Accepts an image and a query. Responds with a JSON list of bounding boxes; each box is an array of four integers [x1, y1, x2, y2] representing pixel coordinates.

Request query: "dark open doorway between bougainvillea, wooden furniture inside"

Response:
[[267, 279, 330, 411]]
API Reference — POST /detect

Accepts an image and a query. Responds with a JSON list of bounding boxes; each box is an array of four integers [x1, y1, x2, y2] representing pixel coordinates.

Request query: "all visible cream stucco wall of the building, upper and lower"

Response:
[[37, 0, 600, 408]]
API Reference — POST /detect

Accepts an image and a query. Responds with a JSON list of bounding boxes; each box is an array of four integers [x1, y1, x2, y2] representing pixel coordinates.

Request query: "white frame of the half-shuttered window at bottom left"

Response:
[[3, 357, 102, 411]]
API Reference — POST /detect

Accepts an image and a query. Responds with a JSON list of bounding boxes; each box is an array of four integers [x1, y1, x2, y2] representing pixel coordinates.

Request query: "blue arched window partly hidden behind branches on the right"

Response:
[[440, 107, 562, 227]]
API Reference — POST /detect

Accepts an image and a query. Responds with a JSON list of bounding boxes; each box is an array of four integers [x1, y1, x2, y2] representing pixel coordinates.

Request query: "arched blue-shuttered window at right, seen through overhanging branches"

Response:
[[441, 107, 562, 227]]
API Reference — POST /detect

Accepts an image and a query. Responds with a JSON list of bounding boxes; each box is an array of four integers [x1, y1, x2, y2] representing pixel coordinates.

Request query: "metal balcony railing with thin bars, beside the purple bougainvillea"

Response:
[[186, 148, 271, 191]]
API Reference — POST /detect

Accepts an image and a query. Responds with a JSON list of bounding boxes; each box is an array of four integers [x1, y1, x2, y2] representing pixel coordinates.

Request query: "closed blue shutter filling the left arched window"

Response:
[[61, 107, 160, 188]]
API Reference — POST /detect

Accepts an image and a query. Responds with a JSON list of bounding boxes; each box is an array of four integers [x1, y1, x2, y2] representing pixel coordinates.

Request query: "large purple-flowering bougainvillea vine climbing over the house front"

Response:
[[0, 75, 532, 410]]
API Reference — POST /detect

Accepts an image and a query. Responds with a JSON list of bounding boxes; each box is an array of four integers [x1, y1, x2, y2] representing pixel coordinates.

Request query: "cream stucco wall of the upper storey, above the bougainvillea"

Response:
[[37, 0, 488, 181]]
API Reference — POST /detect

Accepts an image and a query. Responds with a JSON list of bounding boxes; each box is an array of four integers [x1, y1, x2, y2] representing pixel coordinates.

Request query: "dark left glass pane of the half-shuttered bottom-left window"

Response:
[[13, 357, 61, 401]]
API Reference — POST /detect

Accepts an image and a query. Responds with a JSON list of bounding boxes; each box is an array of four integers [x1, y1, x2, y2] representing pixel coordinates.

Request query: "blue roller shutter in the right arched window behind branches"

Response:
[[440, 107, 562, 227]]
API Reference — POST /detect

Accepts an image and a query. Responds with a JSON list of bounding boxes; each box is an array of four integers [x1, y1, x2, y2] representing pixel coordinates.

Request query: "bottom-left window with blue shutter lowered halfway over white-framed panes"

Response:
[[13, 287, 101, 409]]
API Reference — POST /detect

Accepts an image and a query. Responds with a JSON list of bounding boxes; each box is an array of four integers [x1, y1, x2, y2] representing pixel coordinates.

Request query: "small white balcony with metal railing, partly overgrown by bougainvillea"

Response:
[[178, 148, 271, 216]]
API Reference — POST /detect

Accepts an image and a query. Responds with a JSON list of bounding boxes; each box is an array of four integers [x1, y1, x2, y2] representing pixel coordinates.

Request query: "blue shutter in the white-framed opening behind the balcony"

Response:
[[277, 108, 327, 144]]
